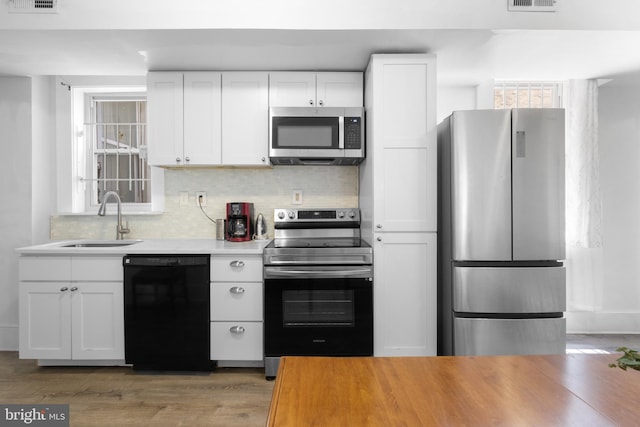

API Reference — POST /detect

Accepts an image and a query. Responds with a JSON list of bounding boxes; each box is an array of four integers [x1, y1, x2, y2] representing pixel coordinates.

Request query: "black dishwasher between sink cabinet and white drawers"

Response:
[[123, 255, 212, 371]]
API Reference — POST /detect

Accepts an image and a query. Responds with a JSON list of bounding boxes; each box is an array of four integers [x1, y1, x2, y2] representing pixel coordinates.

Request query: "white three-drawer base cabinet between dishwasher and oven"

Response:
[[211, 255, 264, 366]]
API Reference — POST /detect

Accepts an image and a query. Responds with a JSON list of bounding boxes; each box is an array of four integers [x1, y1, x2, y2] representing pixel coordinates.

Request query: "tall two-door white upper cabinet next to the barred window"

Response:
[[147, 72, 221, 166]]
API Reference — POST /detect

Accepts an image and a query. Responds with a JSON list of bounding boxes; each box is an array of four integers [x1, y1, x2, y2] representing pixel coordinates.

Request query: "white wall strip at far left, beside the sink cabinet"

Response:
[[0, 77, 31, 350]]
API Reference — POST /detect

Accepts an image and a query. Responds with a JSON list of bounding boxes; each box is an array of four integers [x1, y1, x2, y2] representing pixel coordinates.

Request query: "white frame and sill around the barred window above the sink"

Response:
[[55, 76, 164, 215]]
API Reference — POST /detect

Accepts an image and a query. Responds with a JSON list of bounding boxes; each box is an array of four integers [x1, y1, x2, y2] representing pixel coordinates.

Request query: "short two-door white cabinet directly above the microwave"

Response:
[[269, 71, 363, 107]]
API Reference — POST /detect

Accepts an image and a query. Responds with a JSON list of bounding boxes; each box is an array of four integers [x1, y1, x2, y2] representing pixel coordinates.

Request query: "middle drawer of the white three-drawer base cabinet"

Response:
[[211, 282, 262, 322]]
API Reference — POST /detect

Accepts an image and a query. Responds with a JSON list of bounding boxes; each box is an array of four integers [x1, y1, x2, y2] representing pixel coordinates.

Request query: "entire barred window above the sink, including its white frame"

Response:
[[63, 83, 164, 215]]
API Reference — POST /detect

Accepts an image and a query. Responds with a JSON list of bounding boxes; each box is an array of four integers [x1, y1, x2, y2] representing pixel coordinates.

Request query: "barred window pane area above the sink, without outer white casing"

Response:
[[84, 94, 151, 206]]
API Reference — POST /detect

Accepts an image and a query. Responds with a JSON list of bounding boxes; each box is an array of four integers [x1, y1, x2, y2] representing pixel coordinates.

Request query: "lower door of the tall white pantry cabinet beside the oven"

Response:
[[373, 233, 437, 356]]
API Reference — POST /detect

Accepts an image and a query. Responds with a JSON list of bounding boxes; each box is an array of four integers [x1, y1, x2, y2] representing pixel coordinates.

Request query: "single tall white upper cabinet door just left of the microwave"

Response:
[[222, 71, 269, 166]]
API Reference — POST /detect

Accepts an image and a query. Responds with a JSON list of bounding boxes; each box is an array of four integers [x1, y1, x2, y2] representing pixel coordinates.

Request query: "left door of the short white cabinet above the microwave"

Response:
[[269, 72, 316, 107]]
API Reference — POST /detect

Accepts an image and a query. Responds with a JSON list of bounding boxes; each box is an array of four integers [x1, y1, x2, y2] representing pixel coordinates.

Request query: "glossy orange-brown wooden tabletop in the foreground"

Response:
[[267, 354, 640, 427]]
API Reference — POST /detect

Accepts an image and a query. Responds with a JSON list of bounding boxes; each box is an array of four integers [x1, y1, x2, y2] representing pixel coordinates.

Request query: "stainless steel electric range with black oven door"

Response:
[[264, 209, 373, 378]]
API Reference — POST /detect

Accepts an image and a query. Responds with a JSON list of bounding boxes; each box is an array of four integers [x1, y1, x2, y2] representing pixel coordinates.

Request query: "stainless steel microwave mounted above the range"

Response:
[[269, 107, 365, 165]]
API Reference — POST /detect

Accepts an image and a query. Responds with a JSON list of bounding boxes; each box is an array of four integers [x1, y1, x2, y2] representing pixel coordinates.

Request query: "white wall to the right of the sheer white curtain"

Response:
[[567, 79, 640, 333]]
